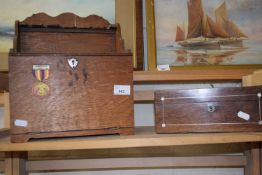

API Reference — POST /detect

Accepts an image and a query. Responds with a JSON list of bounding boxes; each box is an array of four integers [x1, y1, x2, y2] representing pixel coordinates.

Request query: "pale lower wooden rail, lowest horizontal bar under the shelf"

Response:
[[26, 156, 246, 172]]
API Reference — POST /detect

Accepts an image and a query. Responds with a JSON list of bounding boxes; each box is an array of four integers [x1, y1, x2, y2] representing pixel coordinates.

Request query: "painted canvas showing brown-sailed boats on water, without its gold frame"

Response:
[[155, 0, 262, 66]]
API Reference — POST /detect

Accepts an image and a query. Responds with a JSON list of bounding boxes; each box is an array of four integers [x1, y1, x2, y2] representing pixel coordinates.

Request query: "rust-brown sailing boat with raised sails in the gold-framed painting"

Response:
[[176, 0, 247, 48]]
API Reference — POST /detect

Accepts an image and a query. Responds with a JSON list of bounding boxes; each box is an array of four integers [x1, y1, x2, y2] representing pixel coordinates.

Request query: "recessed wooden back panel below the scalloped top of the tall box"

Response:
[[19, 29, 116, 54]]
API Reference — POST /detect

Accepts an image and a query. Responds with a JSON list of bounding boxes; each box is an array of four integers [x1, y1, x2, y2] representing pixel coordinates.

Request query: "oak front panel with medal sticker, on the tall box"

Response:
[[9, 54, 134, 142]]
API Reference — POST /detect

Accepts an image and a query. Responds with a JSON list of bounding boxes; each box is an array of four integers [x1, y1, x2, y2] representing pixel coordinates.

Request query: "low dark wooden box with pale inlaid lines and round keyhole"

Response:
[[155, 86, 262, 133]]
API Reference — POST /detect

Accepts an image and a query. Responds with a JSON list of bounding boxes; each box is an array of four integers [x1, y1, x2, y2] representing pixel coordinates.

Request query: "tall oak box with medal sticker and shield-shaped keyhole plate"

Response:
[[9, 13, 134, 142]]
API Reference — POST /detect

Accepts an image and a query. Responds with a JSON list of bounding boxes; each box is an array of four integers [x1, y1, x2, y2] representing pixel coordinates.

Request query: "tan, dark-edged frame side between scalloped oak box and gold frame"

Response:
[[115, 0, 144, 70]]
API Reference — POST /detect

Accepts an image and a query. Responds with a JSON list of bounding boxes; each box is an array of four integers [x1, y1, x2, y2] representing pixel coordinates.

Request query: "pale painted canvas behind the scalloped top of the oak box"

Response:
[[0, 0, 115, 53]]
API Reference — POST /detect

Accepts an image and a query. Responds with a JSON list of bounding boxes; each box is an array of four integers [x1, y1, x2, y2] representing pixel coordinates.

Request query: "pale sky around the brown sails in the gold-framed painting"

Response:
[[155, 0, 262, 44]]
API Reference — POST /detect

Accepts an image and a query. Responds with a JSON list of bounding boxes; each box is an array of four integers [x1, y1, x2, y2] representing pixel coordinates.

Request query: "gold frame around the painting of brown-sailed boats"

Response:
[[146, 0, 262, 75]]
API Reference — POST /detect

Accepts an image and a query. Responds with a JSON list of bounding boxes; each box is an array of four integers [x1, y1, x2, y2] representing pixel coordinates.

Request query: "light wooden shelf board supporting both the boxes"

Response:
[[0, 127, 262, 151]]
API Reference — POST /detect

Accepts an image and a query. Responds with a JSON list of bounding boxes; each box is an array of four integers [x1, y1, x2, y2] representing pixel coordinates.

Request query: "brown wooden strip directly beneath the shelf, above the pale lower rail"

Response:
[[27, 143, 247, 160]]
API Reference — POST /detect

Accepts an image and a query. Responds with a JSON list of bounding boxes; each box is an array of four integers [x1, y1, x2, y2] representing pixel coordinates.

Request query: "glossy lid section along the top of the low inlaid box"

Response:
[[155, 86, 262, 103]]
